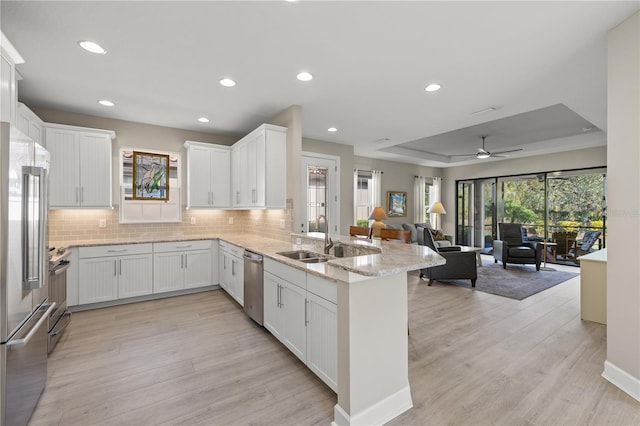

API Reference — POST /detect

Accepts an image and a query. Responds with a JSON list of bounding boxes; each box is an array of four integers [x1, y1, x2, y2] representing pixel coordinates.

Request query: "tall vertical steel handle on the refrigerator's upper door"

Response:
[[22, 166, 48, 291]]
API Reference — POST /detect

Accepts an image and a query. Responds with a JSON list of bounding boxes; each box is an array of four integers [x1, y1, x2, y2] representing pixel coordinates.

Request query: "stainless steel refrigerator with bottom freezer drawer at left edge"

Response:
[[0, 122, 55, 426]]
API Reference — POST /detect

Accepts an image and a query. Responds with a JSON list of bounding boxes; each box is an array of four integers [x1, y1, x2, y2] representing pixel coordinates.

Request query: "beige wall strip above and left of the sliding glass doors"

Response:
[[442, 146, 608, 235]]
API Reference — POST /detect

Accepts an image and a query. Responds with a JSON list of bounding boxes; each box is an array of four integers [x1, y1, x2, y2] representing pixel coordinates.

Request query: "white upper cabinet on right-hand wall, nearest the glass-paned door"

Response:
[[231, 124, 287, 209]]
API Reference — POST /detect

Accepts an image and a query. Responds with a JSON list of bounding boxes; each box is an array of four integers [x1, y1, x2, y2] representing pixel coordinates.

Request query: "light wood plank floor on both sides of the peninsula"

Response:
[[30, 260, 640, 426]]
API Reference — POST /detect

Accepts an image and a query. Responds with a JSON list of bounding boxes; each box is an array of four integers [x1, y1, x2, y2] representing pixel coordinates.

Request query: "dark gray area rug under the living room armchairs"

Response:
[[438, 262, 579, 300]]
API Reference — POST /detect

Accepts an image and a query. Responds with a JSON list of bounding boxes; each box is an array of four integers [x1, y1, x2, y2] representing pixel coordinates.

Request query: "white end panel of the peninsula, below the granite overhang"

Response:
[[333, 272, 413, 426]]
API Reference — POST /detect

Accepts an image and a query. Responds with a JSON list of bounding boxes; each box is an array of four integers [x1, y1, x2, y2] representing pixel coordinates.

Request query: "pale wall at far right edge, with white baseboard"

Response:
[[604, 12, 640, 400]]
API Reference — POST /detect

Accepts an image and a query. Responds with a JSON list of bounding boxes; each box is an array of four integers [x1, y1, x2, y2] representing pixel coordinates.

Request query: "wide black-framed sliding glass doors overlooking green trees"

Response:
[[456, 168, 606, 260]]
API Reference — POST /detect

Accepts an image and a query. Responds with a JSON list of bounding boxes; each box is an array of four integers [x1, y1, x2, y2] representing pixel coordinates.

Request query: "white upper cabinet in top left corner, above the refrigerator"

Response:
[[0, 32, 24, 126]]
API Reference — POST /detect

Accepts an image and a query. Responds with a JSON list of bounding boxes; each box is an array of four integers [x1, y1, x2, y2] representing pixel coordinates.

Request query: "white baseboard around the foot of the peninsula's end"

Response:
[[331, 385, 413, 426]]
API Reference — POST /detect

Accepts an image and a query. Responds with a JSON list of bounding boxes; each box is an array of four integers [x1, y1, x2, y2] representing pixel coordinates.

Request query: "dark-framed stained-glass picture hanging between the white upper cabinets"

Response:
[[133, 151, 169, 201]]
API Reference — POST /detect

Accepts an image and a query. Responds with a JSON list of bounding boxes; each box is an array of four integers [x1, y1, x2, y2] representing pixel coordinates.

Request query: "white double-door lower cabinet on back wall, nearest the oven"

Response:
[[78, 244, 153, 305]]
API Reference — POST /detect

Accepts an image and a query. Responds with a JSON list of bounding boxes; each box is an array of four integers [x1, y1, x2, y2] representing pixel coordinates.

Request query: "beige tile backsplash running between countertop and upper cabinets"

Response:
[[49, 200, 292, 243]]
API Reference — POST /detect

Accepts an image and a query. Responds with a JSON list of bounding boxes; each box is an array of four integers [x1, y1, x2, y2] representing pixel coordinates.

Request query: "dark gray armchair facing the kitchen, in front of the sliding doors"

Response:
[[493, 223, 542, 271]]
